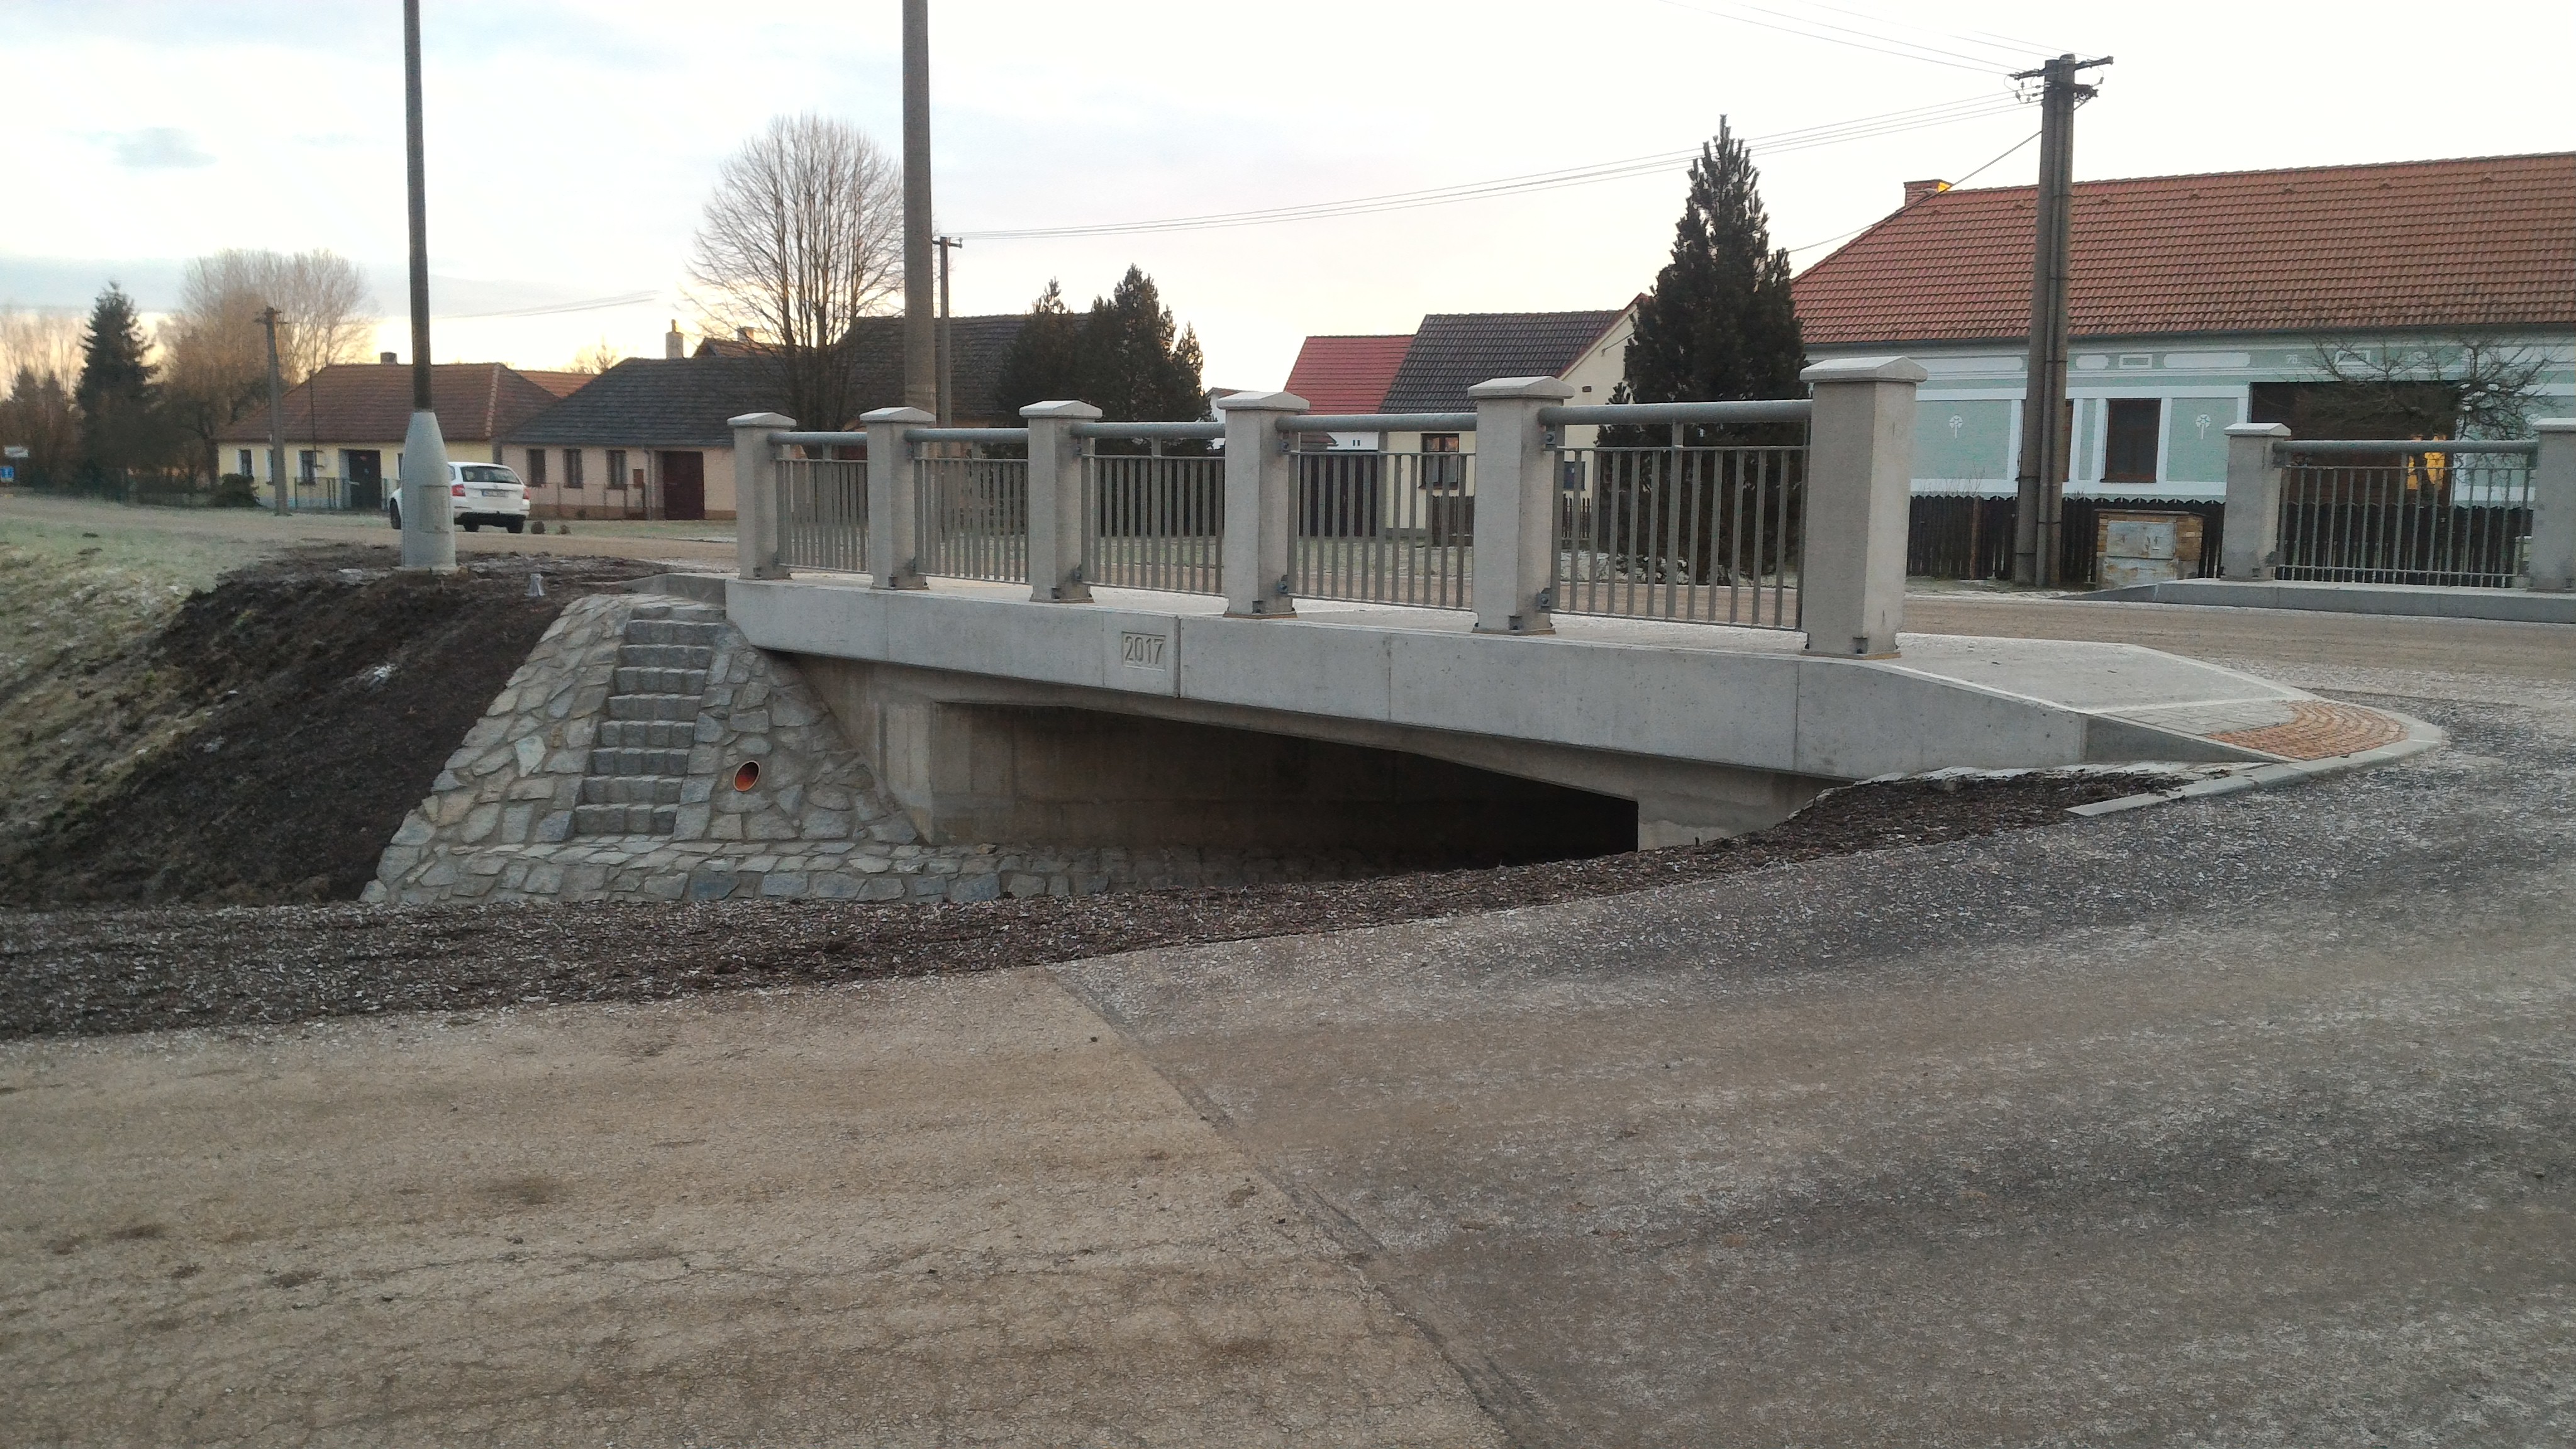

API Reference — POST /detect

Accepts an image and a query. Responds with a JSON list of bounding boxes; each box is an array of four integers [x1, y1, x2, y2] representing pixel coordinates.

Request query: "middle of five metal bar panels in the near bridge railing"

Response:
[[1082, 438, 1226, 593]]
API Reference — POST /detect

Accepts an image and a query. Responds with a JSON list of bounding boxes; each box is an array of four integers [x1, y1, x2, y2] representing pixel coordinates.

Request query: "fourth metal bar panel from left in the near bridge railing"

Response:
[[1291, 443, 1476, 609]]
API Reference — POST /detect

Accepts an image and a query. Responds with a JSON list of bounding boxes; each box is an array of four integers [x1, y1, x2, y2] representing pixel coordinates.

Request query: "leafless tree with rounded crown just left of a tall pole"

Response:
[[688, 113, 904, 428]]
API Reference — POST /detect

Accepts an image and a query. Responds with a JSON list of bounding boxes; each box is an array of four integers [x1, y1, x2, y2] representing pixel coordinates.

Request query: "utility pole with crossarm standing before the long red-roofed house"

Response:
[[2012, 54, 2110, 588]]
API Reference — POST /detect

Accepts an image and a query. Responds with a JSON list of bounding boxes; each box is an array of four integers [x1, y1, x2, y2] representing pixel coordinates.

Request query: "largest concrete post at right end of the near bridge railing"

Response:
[[1798, 358, 1929, 660]]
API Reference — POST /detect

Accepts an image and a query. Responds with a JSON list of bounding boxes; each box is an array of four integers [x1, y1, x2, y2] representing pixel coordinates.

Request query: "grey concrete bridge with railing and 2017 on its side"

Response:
[[690, 358, 2370, 846]]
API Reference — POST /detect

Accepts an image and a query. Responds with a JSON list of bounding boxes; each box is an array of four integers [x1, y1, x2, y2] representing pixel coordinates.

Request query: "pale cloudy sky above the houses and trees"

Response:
[[0, 0, 2576, 387]]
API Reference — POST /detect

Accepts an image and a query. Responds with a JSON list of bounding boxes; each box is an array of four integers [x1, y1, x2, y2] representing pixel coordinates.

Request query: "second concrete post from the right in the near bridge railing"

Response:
[[1466, 377, 1574, 635]]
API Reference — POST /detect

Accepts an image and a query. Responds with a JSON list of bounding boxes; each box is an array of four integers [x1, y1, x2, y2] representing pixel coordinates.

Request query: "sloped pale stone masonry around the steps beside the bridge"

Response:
[[366, 596, 1384, 905]]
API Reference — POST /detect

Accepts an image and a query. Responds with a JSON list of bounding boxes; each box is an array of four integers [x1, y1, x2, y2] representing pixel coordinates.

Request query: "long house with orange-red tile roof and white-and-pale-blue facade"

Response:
[[1793, 152, 2576, 502]]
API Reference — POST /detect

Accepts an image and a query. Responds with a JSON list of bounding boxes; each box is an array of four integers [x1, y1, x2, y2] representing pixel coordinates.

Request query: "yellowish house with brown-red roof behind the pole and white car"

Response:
[[214, 353, 590, 511]]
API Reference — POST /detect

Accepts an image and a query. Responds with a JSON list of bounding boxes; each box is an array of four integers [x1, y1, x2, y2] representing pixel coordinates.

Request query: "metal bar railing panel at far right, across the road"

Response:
[[2272, 438, 2534, 588]]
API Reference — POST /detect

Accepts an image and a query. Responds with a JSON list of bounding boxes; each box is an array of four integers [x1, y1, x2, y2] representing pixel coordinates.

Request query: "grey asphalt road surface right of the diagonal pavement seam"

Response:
[[1056, 636, 2576, 1446]]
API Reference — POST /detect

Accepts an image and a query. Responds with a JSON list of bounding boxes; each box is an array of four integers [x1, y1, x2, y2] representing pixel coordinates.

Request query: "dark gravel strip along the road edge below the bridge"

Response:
[[0, 774, 2158, 1039]]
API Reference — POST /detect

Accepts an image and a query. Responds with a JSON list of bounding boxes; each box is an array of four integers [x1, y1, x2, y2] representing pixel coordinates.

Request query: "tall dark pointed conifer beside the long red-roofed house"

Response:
[[1623, 119, 1806, 441]]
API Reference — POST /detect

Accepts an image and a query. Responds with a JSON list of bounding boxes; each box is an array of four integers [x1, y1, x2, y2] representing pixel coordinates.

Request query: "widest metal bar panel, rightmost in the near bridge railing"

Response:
[[1551, 446, 1806, 629]]
